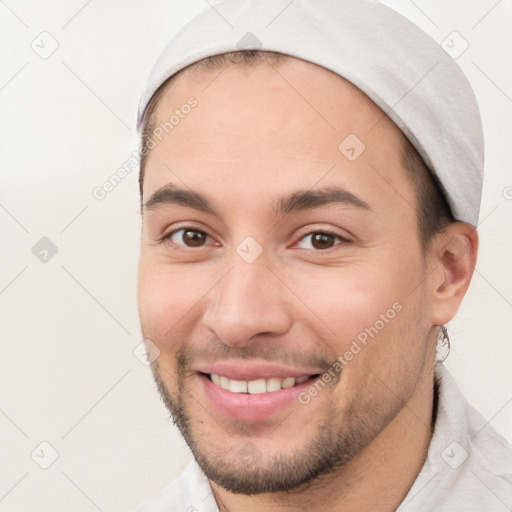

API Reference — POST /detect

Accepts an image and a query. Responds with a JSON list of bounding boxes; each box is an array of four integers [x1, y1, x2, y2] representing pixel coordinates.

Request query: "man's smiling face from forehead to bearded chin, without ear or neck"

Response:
[[138, 58, 431, 494]]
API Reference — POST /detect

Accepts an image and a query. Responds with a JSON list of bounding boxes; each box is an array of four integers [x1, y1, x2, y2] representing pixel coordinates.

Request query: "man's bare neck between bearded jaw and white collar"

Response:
[[210, 368, 434, 512]]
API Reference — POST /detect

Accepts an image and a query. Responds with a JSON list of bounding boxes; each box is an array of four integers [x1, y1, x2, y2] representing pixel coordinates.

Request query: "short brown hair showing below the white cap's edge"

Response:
[[139, 50, 455, 251]]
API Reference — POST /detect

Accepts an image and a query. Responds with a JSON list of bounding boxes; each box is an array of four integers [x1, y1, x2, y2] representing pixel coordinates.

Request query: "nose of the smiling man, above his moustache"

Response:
[[203, 255, 292, 347]]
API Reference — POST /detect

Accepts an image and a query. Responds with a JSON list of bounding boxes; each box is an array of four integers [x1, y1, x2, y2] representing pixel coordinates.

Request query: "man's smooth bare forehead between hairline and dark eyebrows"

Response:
[[144, 57, 414, 214]]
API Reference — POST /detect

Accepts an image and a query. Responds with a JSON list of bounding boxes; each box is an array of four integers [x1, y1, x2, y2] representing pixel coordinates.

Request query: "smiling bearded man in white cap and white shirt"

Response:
[[136, 0, 512, 512]]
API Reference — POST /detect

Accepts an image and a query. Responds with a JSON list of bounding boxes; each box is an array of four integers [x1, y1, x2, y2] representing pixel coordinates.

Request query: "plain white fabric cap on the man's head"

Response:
[[137, 0, 484, 226]]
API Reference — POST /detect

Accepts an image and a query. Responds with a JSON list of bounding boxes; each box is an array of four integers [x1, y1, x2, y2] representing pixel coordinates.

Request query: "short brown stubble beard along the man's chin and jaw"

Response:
[[148, 361, 412, 495]]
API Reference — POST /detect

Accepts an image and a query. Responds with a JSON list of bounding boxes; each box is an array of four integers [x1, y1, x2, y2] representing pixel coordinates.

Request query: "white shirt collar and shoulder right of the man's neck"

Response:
[[399, 364, 512, 512]]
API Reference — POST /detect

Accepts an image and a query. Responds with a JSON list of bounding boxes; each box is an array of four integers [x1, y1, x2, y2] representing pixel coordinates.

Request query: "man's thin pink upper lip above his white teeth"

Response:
[[194, 361, 322, 381]]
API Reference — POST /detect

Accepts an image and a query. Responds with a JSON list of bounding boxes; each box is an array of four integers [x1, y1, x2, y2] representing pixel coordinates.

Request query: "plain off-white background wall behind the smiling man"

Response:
[[0, 0, 512, 512]]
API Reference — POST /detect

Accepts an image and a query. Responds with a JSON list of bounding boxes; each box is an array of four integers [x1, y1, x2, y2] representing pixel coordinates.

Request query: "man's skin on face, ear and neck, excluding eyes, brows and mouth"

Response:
[[138, 58, 477, 512]]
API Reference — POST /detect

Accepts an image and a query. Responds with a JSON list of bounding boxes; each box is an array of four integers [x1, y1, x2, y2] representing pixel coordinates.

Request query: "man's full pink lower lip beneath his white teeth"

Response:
[[198, 374, 316, 422]]
